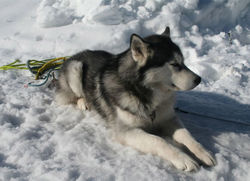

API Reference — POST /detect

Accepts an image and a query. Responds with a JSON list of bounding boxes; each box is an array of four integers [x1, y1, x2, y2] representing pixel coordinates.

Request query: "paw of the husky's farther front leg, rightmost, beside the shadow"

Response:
[[195, 146, 216, 166]]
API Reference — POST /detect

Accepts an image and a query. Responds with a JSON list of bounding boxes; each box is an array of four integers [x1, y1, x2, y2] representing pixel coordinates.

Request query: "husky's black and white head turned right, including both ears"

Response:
[[130, 27, 201, 90]]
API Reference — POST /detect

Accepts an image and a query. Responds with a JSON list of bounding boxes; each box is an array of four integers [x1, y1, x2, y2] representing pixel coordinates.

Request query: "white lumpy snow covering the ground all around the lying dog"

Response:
[[0, 0, 250, 181]]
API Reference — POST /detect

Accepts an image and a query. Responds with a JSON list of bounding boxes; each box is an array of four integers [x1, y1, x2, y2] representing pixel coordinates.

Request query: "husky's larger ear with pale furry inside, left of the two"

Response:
[[130, 34, 148, 66]]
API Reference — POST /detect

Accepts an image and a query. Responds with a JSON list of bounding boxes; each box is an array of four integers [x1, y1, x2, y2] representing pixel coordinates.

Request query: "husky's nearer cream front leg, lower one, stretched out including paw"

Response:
[[117, 128, 199, 171]]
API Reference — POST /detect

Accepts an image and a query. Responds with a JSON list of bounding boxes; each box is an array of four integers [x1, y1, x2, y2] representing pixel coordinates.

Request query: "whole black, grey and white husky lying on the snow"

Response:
[[56, 27, 216, 171]]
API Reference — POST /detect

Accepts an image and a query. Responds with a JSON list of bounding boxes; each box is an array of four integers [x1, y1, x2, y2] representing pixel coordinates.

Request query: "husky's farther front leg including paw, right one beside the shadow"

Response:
[[167, 117, 216, 166]]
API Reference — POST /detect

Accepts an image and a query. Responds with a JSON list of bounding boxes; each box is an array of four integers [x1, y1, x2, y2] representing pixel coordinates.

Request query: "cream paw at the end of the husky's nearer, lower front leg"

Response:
[[170, 153, 199, 172]]
